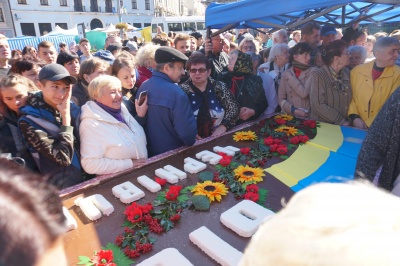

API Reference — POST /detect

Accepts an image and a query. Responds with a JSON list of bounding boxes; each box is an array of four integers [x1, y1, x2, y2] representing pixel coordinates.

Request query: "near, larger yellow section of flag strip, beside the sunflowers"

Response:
[[265, 143, 330, 187]]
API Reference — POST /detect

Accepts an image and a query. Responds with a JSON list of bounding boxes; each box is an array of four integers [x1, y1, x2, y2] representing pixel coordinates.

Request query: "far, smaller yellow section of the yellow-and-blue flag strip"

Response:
[[307, 122, 343, 152]]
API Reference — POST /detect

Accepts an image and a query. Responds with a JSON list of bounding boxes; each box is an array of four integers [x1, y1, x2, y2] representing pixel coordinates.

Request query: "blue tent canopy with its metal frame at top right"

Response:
[[205, 0, 400, 30]]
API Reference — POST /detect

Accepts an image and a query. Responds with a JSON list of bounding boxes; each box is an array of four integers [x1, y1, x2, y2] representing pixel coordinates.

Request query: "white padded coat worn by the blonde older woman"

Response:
[[79, 101, 147, 175]]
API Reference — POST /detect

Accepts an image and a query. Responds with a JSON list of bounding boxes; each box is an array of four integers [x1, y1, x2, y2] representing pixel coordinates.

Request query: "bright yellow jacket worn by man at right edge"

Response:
[[349, 60, 400, 126]]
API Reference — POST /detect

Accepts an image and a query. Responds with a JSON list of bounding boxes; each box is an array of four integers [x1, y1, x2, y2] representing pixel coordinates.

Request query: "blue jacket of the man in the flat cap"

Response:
[[136, 71, 197, 156]]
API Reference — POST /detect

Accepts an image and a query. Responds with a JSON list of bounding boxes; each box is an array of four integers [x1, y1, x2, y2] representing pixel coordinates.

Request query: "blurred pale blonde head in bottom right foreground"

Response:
[[239, 182, 400, 266]]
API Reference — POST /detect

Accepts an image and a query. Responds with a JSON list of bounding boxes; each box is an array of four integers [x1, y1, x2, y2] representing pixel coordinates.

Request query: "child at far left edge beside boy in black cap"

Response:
[[0, 75, 37, 171]]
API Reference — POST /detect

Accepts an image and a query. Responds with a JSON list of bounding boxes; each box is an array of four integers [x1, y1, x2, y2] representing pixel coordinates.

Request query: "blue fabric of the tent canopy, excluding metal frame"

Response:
[[205, 0, 400, 29]]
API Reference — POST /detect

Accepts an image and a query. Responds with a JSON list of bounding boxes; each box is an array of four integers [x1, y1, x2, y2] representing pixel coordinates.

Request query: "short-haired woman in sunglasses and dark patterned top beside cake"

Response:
[[180, 53, 239, 139]]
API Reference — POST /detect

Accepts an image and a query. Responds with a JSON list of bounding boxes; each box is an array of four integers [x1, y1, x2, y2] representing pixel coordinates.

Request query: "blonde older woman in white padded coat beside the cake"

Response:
[[79, 76, 147, 175]]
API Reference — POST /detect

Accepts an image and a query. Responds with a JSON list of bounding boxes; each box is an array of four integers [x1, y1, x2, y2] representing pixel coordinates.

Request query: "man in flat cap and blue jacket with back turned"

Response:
[[136, 46, 197, 156]]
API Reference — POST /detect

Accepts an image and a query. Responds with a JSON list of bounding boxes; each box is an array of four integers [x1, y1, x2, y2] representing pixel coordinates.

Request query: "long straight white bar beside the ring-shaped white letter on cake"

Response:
[[189, 226, 243, 266]]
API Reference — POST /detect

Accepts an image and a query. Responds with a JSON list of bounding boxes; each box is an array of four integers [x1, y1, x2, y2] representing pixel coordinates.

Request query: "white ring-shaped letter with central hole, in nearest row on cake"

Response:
[[220, 200, 274, 237]]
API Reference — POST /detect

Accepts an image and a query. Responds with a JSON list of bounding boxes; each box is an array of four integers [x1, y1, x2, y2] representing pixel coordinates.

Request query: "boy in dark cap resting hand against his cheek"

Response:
[[18, 64, 83, 189]]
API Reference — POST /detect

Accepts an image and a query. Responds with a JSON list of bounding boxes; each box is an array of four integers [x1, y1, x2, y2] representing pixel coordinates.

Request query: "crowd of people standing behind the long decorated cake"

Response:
[[0, 22, 400, 189]]
